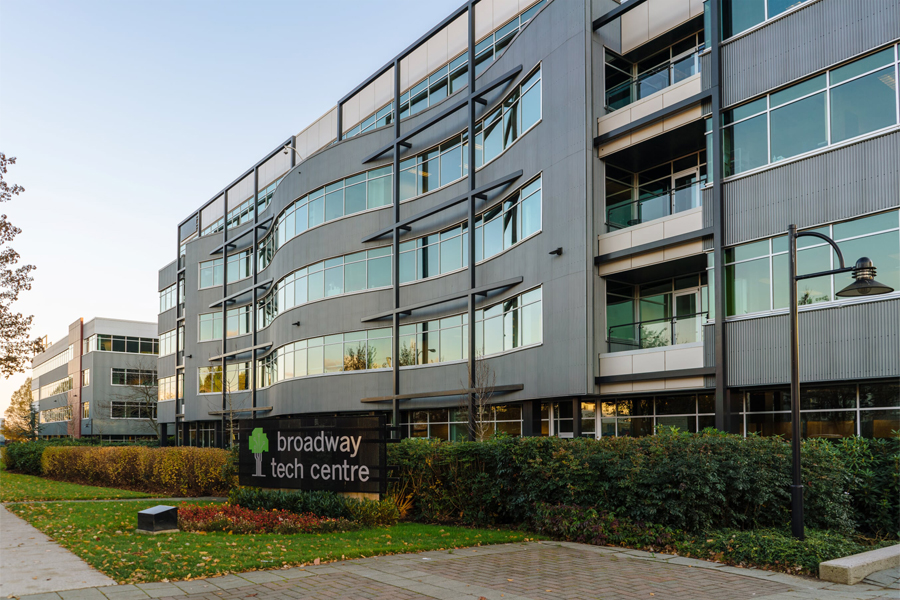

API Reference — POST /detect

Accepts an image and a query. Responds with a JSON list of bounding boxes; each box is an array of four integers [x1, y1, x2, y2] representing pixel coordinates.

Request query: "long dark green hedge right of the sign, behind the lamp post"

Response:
[[388, 430, 900, 535]]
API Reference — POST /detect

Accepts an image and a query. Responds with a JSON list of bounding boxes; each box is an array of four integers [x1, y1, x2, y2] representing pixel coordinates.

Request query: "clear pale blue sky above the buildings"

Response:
[[0, 0, 462, 413]]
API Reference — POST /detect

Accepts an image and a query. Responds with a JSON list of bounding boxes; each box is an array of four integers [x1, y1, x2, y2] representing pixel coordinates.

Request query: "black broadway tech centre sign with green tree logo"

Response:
[[238, 415, 388, 494]]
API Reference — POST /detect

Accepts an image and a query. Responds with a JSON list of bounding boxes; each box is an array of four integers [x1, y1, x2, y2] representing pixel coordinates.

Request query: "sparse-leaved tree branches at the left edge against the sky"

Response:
[[0, 152, 43, 377]]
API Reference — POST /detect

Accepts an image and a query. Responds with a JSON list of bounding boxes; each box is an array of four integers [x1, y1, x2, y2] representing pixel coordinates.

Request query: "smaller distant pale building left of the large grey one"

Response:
[[31, 317, 159, 441]]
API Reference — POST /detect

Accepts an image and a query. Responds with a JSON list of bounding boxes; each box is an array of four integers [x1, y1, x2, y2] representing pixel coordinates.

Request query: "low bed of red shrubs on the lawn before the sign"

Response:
[[178, 503, 359, 535]]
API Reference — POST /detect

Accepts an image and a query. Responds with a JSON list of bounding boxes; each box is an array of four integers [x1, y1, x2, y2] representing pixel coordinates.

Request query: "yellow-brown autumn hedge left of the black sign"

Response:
[[41, 446, 235, 496]]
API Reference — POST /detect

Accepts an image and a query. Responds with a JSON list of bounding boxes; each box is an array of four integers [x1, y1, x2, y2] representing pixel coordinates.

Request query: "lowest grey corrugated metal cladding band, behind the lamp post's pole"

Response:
[[725, 298, 900, 386]]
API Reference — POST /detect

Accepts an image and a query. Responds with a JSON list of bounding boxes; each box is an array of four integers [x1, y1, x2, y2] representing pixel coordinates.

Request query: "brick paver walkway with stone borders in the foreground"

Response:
[[8, 542, 900, 600]]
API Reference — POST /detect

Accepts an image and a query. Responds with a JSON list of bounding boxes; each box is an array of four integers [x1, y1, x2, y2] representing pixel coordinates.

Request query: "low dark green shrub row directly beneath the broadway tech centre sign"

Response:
[[228, 487, 400, 527]]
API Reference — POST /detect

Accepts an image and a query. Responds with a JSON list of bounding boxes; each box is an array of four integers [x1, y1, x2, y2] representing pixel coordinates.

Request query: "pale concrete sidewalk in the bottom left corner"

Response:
[[0, 506, 116, 598]]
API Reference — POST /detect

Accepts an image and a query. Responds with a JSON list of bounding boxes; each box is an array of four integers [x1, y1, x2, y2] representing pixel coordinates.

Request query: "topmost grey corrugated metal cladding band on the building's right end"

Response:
[[721, 0, 900, 106]]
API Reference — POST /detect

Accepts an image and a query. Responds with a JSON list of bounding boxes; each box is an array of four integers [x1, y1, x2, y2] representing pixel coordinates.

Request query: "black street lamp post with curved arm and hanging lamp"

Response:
[[788, 225, 894, 540]]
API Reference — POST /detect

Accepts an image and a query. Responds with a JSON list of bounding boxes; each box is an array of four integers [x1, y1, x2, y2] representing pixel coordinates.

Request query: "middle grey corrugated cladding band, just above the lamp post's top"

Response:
[[724, 132, 900, 246]]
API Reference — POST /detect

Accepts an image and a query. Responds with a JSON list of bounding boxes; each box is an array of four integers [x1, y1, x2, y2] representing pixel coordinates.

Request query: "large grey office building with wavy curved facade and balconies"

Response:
[[158, 0, 900, 445]]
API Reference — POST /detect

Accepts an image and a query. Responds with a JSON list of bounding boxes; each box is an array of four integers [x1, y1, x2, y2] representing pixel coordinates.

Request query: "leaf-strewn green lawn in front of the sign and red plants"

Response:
[[8, 501, 534, 583]]
